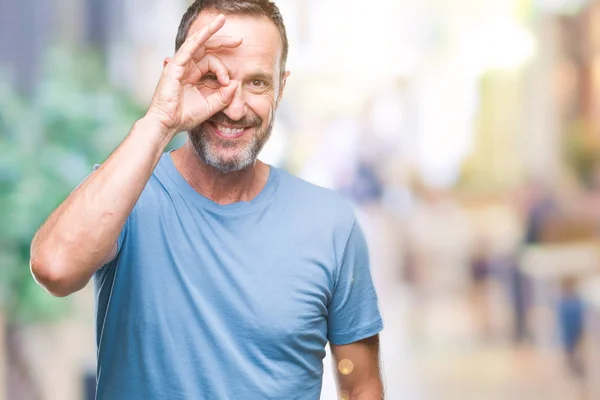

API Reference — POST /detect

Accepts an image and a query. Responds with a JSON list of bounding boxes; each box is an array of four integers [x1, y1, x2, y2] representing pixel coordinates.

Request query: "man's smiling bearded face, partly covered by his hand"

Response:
[[188, 11, 285, 172]]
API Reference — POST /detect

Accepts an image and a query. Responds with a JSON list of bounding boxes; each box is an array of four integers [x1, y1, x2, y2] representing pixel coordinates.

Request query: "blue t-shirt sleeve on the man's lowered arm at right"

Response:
[[327, 217, 383, 345]]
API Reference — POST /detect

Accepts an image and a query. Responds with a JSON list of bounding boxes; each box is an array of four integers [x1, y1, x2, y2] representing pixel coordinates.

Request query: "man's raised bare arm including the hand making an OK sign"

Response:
[[30, 15, 241, 296]]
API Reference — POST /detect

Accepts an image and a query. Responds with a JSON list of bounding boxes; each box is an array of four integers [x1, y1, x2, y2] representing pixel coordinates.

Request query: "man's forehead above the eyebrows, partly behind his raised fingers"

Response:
[[188, 10, 283, 61]]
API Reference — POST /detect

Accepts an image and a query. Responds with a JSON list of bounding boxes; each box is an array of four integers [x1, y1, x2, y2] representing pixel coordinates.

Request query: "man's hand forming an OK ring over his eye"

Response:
[[146, 15, 242, 136]]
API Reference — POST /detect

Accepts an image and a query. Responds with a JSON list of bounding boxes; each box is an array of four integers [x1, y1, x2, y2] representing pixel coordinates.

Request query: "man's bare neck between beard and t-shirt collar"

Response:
[[171, 142, 269, 205]]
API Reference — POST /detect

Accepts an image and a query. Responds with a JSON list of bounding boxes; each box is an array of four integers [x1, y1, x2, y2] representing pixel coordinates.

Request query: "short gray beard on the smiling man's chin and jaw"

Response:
[[188, 118, 273, 173]]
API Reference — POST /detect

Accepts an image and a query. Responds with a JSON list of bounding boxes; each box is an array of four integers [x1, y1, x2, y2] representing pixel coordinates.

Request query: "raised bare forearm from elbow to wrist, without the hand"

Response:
[[31, 119, 172, 296]]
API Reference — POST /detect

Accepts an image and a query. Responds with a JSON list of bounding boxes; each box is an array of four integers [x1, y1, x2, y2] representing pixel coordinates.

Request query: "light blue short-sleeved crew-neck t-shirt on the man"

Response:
[[94, 153, 382, 400]]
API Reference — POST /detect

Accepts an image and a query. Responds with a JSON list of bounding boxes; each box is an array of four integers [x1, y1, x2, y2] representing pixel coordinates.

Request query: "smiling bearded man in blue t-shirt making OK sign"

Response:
[[31, 0, 383, 400]]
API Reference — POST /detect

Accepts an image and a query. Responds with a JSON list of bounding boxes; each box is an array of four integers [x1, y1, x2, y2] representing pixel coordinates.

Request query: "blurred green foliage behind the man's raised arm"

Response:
[[0, 49, 143, 322]]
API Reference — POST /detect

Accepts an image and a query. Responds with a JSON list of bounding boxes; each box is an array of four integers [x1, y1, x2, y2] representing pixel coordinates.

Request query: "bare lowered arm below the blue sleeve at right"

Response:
[[330, 335, 383, 400]]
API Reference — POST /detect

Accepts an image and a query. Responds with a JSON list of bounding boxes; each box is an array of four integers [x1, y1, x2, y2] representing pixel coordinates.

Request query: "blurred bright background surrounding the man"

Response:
[[0, 0, 600, 400]]
